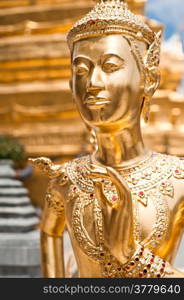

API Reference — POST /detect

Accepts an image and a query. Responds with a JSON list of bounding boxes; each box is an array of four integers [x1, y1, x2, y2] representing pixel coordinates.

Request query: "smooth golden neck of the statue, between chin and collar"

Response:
[[92, 116, 147, 167]]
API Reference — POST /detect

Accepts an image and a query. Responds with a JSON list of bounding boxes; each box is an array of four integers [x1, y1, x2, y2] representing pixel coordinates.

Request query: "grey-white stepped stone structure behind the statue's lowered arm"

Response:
[[0, 159, 40, 278]]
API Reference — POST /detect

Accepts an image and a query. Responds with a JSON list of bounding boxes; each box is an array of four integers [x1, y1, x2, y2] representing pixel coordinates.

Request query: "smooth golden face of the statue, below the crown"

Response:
[[72, 35, 145, 128]]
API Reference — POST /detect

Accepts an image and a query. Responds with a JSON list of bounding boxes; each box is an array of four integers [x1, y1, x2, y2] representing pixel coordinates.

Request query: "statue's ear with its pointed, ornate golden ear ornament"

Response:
[[144, 31, 162, 97]]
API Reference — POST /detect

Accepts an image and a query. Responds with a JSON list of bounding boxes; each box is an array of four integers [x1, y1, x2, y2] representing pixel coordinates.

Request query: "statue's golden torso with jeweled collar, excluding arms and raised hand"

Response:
[[38, 152, 184, 277]]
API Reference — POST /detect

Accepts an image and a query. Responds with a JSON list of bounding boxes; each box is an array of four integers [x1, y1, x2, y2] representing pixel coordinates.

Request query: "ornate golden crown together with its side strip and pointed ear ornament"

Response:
[[67, 0, 162, 81]]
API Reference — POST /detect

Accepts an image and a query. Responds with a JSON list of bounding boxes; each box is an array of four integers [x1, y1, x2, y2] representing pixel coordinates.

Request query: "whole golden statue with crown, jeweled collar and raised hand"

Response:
[[29, 0, 184, 278]]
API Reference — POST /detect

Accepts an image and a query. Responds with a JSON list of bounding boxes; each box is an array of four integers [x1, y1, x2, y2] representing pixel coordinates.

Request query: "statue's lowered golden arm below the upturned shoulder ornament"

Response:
[[40, 179, 65, 278]]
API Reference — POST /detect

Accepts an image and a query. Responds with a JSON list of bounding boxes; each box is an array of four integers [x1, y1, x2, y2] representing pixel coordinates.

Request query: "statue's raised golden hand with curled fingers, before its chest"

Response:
[[89, 167, 135, 262]]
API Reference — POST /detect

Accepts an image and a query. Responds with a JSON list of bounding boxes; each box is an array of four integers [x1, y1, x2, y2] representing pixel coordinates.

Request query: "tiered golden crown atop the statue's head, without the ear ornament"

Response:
[[67, 0, 155, 49]]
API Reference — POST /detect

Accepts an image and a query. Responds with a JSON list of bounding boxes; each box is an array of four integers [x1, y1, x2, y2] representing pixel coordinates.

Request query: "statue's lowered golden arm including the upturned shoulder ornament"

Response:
[[29, 157, 66, 277]]
